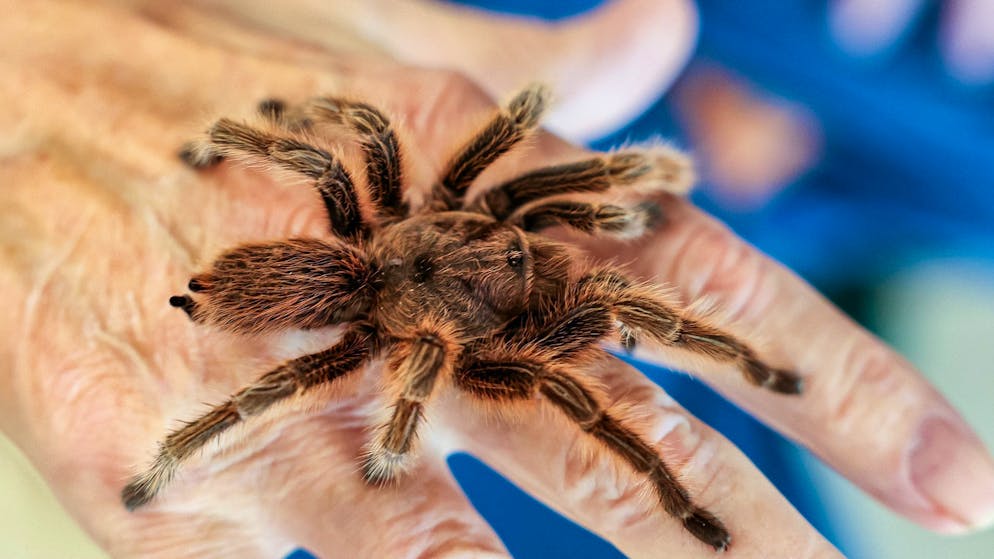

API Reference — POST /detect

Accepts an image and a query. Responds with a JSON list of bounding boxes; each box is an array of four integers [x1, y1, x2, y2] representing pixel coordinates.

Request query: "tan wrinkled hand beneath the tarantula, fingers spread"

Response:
[[0, 3, 994, 558]]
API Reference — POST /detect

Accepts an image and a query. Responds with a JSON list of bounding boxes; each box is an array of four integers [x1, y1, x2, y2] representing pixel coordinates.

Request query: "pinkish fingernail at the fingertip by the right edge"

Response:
[[911, 417, 994, 531]]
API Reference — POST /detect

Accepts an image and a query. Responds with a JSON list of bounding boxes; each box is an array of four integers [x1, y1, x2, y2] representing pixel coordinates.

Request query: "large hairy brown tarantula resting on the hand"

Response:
[[122, 86, 801, 550]]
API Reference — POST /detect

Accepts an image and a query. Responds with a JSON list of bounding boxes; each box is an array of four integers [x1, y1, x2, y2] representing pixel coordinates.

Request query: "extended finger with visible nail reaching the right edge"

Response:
[[576, 198, 994, 532]]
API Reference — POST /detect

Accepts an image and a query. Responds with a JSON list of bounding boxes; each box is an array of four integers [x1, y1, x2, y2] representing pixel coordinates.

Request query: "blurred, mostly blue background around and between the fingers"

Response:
[[0, 0, 994, 559]]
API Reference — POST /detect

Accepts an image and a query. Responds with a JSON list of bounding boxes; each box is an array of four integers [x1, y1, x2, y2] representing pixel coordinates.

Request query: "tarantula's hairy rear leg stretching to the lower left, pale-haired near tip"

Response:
[[121, 330, 372, 510]]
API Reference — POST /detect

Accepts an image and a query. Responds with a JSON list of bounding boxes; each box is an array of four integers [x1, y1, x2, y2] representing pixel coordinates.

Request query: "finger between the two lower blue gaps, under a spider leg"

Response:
[[440, 358, 839, 558]]
